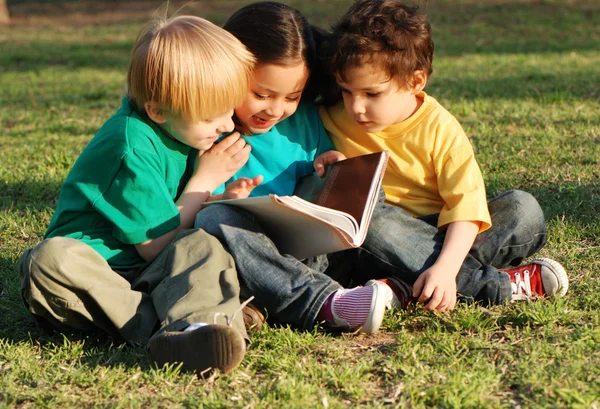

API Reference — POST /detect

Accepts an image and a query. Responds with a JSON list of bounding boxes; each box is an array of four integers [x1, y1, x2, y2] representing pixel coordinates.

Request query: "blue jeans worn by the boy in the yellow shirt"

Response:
[[356, 190, 547, 304]]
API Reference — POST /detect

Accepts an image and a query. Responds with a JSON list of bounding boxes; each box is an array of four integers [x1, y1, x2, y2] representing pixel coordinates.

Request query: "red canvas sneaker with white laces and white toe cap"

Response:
[[501, 258, 569, 301]]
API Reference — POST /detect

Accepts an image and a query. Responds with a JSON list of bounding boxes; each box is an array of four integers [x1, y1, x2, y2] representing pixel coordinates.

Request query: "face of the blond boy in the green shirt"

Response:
[[163, 109, 234, 151]]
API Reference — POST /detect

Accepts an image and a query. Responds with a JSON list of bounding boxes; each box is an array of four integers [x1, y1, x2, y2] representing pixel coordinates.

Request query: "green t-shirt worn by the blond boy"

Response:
[[45, 98, 190, 270]]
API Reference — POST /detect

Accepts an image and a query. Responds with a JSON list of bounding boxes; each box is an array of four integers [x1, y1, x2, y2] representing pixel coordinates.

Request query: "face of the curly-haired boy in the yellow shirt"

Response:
[[337, 64, 425, 133]]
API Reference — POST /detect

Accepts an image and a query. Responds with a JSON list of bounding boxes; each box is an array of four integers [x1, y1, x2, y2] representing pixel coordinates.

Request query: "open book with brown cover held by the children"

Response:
[[206, 151, 389, 260]]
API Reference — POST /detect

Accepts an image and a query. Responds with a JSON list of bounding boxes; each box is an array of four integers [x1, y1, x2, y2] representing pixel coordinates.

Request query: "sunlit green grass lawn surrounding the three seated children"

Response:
[[0, 0, 600, 408]]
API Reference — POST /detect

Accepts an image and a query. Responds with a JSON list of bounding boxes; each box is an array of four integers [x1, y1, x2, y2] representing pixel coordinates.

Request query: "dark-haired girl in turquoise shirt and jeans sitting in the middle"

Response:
[[196, 2, 404, 333]]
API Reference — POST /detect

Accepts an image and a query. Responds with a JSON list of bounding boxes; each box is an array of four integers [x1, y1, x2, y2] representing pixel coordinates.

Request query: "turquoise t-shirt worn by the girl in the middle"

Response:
[[213, 102, 335, 196]]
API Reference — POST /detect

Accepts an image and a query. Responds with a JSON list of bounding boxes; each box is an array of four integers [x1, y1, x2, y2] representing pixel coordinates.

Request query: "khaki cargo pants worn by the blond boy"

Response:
[[18, 229, 248, 344]]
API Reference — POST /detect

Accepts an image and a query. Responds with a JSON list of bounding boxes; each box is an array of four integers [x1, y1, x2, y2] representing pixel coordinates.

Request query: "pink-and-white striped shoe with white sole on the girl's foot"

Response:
[[317, 282, 393, 334]]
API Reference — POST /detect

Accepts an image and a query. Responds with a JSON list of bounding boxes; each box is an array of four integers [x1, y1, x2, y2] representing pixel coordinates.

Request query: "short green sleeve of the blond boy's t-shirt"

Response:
[[94, 150, 180, 244]]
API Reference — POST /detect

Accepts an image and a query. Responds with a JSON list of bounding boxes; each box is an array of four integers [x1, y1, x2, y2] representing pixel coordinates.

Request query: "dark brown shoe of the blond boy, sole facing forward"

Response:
[[148, 324, 246, 376]]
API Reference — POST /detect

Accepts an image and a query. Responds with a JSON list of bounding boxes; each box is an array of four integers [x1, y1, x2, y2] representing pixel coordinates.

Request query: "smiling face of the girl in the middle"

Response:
[[235, 62, 309, 134]]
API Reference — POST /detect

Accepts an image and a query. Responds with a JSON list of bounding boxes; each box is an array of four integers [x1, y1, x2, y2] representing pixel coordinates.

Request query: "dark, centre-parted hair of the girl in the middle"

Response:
[[223, 1, 323, 101]]
